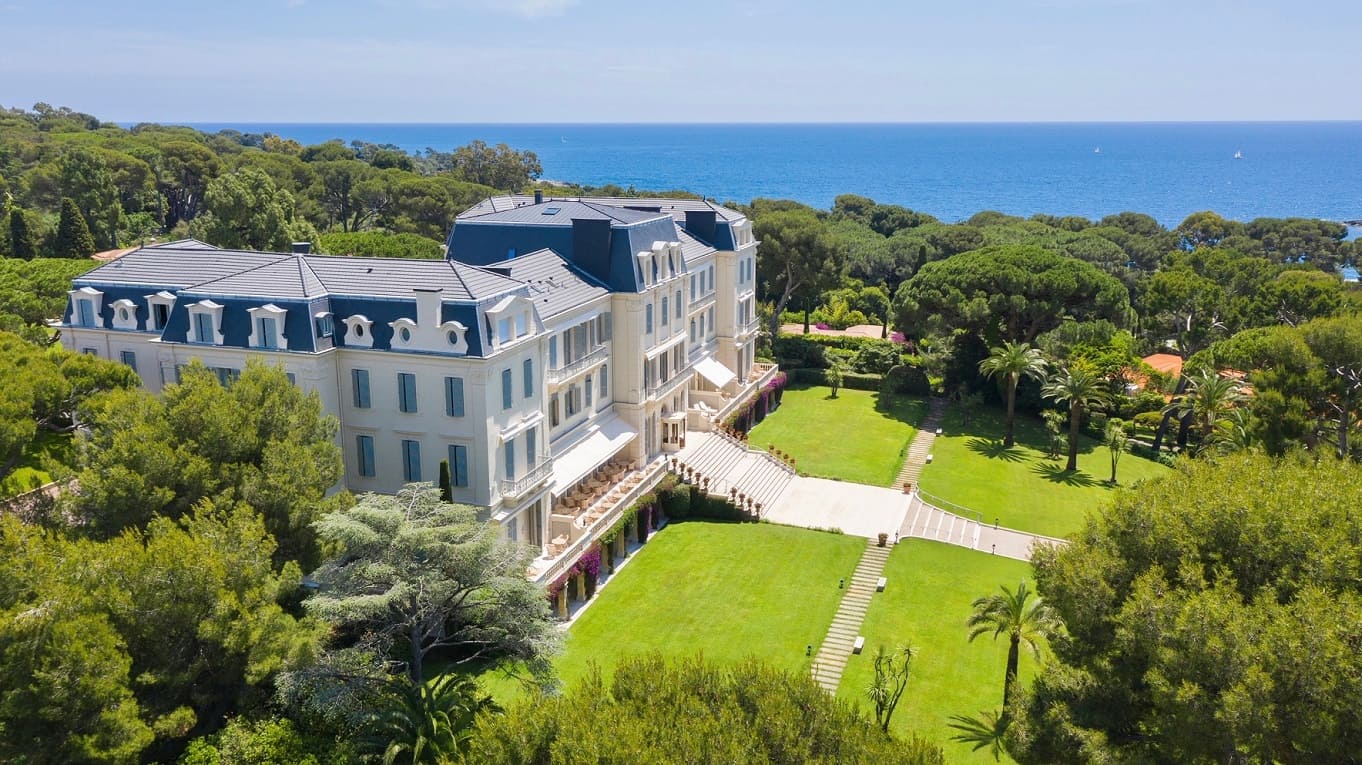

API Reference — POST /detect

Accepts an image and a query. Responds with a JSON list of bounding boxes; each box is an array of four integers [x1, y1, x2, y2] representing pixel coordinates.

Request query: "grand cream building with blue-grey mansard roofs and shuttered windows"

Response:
[[61, 195, 775, 580]]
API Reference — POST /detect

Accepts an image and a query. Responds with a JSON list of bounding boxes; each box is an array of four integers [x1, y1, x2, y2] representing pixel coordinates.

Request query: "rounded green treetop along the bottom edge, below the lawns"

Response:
[[470, 647, 944, 765]]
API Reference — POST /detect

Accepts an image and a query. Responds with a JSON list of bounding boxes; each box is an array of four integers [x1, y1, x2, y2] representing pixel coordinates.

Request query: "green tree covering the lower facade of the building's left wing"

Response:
[[68, 361, 347, 565]]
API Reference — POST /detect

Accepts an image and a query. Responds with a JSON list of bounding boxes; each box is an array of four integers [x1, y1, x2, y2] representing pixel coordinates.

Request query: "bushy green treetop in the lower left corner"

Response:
[[0, 501, 317, 765]]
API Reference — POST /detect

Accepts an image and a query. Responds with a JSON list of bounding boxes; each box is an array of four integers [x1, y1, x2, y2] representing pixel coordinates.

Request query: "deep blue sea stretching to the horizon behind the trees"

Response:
[[183, 123, 1362, 226]]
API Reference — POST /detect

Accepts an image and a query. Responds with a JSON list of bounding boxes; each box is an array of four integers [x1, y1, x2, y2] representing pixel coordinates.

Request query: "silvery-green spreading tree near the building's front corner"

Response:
[[304, 485, 557, 685]]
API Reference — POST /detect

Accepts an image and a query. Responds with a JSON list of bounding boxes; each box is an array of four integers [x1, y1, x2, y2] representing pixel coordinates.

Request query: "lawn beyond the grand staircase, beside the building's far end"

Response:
[[749, 387, 926, 486]]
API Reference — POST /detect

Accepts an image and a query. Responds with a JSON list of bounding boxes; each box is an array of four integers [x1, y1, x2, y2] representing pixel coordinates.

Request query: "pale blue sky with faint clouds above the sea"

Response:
[[0, 0, 1362, 123]]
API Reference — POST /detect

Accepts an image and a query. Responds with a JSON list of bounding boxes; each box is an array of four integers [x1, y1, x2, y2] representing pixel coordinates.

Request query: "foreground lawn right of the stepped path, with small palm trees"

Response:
[[838, 539, 1036, 764]]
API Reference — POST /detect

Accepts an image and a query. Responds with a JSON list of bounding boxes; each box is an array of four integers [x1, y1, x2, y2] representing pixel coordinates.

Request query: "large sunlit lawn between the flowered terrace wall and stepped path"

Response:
[[482, 521, 865, 701]]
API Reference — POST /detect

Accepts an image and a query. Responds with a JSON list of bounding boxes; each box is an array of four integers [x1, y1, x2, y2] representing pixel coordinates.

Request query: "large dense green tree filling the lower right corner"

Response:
[[1008, 453, 1362, 762]]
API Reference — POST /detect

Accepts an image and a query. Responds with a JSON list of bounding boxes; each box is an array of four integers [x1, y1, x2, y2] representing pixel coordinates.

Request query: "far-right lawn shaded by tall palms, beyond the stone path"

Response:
[[921, 406, 1169, 536]]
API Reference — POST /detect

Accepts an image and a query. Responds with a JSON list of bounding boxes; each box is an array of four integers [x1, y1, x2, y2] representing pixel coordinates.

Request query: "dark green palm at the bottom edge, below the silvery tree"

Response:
[[366, 674, 494, 765]]
